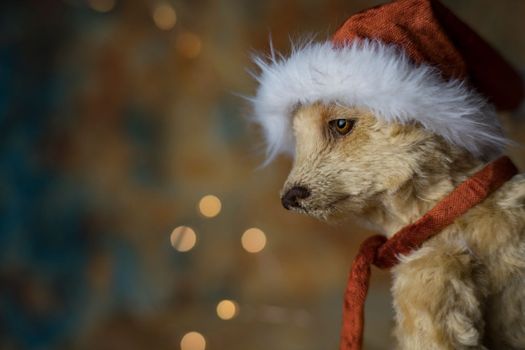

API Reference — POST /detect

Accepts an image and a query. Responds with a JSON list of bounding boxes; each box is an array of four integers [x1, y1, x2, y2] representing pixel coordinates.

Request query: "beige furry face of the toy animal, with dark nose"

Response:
[[281, 103, 436, 220]]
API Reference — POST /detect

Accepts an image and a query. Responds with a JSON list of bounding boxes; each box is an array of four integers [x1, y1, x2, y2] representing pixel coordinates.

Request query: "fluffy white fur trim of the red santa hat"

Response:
[[252, 40, 506, 161]]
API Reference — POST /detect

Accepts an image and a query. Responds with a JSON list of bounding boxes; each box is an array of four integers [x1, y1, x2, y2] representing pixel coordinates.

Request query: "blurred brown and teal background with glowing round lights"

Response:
[[0, 0, 525, 350]]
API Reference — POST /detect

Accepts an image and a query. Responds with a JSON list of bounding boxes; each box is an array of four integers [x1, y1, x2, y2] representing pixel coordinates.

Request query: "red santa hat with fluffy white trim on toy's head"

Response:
[[253, 0, 524, 160]]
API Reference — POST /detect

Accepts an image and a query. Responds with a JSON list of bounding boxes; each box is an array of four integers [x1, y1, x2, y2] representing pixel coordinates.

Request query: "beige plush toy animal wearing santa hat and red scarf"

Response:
[[253, 0, 525, 350]]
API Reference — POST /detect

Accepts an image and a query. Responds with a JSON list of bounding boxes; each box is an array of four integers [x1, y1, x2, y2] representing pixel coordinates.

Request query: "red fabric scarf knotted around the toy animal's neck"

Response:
[[339, 156, 518, 350]]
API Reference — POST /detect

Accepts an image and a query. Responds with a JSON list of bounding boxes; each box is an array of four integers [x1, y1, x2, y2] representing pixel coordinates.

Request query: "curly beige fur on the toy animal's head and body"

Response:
[[283, 104, 525, 350]]
